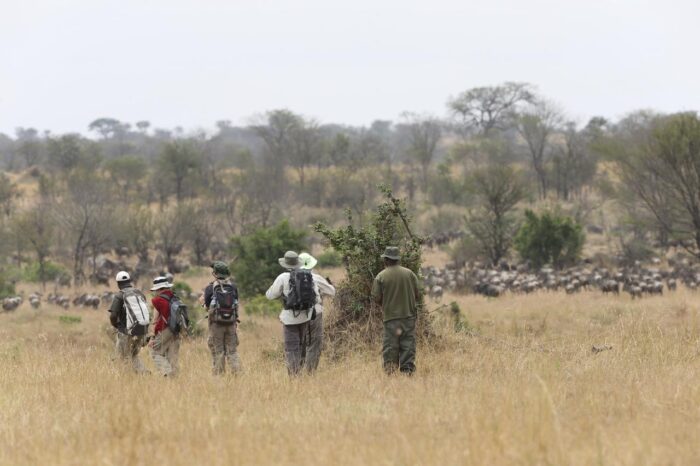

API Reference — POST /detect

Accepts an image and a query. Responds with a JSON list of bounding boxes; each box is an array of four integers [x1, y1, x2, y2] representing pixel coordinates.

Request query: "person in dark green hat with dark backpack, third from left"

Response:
[[204, 261, 241, 375]]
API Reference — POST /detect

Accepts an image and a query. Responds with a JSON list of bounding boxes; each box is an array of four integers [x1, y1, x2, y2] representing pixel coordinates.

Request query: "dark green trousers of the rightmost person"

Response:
[[382, 317, 416, 374]]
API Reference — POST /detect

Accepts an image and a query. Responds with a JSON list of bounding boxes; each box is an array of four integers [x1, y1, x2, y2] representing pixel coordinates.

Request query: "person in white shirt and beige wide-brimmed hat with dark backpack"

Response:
[[265, 251, 321, 376]]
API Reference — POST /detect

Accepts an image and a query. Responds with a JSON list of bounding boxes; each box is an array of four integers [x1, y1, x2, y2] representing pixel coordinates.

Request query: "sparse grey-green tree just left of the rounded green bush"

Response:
[[467, 164, 525, 265]]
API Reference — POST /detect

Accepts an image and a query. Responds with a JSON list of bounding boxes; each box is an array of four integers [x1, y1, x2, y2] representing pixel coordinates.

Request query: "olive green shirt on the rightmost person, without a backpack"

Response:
[[372, 265, 419, 322]]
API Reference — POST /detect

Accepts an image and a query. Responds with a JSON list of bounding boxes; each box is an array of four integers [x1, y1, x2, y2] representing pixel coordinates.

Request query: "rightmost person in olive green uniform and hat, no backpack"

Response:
[[372, 247, 420, 375]]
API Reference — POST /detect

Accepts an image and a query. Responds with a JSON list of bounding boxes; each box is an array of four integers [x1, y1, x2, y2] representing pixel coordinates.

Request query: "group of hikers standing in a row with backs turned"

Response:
[[109, 247, 420, 377]]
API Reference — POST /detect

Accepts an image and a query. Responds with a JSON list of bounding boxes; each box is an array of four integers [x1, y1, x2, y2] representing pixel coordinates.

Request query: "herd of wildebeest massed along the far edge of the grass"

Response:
[[1, 231, 700, 311]]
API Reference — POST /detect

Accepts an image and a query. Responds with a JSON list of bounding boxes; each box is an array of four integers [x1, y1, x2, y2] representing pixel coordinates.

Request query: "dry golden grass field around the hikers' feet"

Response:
[[0, 278, 700, 465]]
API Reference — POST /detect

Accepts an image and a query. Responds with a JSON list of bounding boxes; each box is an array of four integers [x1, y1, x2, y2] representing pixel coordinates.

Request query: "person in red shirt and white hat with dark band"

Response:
[[149, 277, 180, 377]]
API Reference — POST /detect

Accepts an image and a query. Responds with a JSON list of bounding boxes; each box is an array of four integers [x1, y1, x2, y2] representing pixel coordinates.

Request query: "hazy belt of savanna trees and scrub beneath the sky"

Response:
[[0, 82, 700, 290]]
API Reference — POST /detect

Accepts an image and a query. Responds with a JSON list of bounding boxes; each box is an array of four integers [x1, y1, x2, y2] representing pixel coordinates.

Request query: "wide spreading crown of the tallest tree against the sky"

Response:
[[447, 82, 535, 136]]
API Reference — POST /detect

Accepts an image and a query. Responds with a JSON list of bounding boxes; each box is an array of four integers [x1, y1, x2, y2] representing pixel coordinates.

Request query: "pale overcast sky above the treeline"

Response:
[[0, 0, 700, 134]]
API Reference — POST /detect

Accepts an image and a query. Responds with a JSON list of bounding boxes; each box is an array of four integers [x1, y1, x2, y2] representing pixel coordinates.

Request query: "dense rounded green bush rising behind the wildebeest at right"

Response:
[[515, 210, 585, 268]]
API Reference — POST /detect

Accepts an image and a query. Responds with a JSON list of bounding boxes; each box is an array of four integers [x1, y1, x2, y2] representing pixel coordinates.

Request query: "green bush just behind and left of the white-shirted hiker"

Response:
[[231, 220, 306, 296]]
